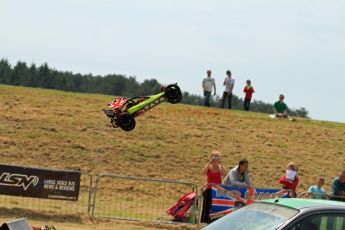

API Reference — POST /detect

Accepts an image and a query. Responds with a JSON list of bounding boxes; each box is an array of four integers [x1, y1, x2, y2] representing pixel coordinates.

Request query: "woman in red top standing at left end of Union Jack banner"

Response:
[[201, 151, 226, 223]]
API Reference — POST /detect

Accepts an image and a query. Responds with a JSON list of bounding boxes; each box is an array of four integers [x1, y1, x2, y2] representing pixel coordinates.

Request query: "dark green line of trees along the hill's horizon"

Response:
[[0, 59, 308, 117]]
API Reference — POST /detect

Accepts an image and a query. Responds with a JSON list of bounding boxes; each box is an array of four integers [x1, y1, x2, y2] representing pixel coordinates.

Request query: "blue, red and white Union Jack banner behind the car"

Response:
[[210, 185, 289, 218]]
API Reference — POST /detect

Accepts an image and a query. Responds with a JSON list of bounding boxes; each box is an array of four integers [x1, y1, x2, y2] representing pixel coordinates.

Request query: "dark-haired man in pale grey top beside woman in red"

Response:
[[223, 159, 252, 188]]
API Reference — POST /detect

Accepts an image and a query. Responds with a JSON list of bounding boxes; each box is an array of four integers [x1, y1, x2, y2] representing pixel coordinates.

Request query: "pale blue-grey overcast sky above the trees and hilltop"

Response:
[[0, 0, 345, 122]]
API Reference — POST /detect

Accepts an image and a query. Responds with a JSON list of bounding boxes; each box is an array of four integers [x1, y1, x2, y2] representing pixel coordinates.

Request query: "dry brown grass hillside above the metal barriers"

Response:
[[0, 85, 345, 228]]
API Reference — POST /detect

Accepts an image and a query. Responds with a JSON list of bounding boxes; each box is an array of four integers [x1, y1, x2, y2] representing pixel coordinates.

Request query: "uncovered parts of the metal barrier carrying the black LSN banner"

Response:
[[0, 173, 92, 215]]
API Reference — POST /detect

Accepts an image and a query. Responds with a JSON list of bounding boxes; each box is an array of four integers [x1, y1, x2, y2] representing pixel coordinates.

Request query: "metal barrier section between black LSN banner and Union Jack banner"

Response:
[[91, 174, 198, 223]]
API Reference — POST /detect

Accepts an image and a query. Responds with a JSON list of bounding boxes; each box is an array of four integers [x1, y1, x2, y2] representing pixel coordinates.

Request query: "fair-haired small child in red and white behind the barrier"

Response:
[[279, 162, 299, 198]]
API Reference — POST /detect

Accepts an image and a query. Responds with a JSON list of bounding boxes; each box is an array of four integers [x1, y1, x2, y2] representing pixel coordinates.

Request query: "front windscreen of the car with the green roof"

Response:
[[204, 203, 298, 230]]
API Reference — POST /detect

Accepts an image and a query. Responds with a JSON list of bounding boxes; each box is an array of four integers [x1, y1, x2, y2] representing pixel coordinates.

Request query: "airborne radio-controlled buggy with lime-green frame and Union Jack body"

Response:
[[104, 84, 182, 131]]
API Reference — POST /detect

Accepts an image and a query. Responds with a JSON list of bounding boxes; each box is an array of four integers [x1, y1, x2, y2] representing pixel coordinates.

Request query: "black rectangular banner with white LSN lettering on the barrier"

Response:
[[0, 165, 81, 201]]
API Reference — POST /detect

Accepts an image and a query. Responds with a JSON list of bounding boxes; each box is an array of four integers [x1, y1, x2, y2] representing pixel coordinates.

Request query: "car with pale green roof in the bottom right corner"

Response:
[[204, 198, 345, 230]]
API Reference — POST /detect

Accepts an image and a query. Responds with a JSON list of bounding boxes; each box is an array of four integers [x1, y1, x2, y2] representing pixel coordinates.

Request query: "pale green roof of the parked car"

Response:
[[258, 198, 345, 209]]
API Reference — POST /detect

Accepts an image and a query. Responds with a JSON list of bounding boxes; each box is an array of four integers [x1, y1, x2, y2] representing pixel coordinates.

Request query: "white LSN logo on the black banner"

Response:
[[0, 172, 39, 191]]
